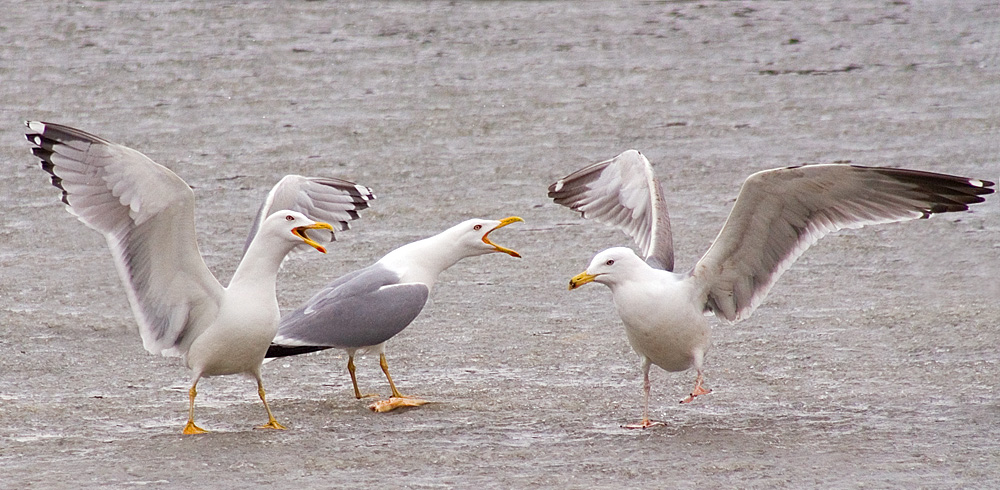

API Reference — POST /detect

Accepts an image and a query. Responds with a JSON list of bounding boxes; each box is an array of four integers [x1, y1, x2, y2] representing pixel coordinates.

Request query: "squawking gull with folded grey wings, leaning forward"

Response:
[[267, 216, 523, 412]]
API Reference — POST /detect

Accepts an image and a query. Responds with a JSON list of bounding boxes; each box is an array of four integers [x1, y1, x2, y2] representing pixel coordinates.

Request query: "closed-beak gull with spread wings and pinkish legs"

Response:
[[548, 150, 994, 428]]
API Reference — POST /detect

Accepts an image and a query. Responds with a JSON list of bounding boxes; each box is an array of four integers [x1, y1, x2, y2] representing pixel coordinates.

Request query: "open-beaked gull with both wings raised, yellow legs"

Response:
[[26, 121, 372, 434]]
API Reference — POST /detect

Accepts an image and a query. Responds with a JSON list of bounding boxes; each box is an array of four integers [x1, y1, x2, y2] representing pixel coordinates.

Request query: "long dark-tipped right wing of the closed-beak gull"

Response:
[[692, 165, 994, 321]]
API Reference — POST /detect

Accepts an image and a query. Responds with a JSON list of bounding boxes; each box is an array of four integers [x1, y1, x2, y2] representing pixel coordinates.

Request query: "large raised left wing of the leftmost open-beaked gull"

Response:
[[26, 121, 223, 355]]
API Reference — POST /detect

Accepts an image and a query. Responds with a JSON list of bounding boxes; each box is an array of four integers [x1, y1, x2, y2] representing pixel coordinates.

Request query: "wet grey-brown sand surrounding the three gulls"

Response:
[[0, 1, 1000, 488]]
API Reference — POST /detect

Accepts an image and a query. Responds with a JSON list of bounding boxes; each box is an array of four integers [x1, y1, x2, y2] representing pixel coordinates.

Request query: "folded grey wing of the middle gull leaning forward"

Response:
[[274, 264, 430, 349]]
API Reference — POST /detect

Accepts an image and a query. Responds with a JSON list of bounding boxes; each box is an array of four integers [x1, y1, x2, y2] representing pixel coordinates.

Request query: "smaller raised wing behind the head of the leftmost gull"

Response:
[[243, 175, 375, 253]]
